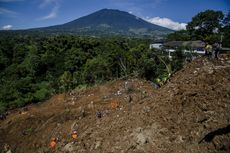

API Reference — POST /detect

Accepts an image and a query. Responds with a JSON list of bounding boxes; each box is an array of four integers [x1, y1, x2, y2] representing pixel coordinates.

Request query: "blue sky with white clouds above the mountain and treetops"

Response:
[[0, 0, 230, 30]]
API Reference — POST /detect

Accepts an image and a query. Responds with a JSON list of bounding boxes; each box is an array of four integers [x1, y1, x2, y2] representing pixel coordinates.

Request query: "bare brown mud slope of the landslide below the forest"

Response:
[[0, 55, 230, 153]]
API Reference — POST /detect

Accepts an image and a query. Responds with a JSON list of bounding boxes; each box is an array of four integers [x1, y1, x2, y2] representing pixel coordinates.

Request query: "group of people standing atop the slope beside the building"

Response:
[[205, 43, 221, 59]]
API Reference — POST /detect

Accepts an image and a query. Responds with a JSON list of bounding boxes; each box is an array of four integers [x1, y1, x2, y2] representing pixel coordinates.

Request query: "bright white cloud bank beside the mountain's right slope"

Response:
[[145, 17, 187, 30]]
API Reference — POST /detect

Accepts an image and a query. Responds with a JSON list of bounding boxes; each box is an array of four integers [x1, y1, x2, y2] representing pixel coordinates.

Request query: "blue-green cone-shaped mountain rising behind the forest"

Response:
[[40, 8, 172, 37]]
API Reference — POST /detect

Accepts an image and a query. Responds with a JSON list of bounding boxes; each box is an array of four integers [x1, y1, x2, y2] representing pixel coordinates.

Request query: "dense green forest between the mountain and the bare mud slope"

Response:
[[0, 35, 183, 112]]
